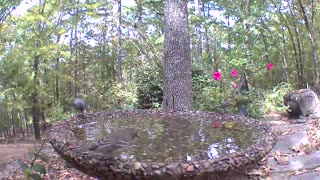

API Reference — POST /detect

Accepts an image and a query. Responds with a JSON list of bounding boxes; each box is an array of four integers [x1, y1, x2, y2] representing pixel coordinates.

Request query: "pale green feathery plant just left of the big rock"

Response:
[[263, 82, 292, 113]]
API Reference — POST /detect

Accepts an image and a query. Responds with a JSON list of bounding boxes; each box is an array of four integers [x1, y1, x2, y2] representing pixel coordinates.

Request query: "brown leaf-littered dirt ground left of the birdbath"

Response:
[[0, 141, 94, 180]]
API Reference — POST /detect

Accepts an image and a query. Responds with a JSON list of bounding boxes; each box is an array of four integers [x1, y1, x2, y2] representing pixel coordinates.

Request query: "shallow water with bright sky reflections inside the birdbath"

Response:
[[73, 118, 259, 162]]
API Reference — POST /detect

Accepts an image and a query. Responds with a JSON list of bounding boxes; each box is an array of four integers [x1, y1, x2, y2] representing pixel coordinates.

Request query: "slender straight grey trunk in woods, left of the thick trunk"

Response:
[[117, 0, 122, 83]]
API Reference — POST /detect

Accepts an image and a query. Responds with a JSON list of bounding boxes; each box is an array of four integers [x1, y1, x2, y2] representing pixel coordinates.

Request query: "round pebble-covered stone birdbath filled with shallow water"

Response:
[[49, 110, 275, 179]]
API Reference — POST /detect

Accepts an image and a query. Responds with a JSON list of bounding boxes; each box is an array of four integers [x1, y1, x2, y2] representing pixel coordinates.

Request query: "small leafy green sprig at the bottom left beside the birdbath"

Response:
[[20, 141, 47, 180]]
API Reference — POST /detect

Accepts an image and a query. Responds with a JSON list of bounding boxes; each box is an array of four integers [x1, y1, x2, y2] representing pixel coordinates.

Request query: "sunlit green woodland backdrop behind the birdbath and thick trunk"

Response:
[[0, 0, 320, 140]]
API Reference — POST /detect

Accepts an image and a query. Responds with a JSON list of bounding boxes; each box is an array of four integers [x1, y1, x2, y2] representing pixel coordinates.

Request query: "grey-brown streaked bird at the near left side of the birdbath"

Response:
[[76, 128, 139, 155]]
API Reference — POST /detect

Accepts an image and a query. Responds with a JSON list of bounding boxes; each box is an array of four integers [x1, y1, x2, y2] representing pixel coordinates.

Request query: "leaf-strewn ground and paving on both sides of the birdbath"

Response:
[[0, 113, 320, 180]]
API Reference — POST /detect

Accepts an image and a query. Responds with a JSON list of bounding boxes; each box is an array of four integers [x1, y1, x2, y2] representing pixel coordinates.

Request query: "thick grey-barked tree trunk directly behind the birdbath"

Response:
[[163, 0, 192, 110]]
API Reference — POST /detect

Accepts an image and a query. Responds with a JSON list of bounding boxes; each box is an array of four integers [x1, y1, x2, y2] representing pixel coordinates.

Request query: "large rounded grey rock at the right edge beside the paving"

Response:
[[283, 89, 320, 118]]
